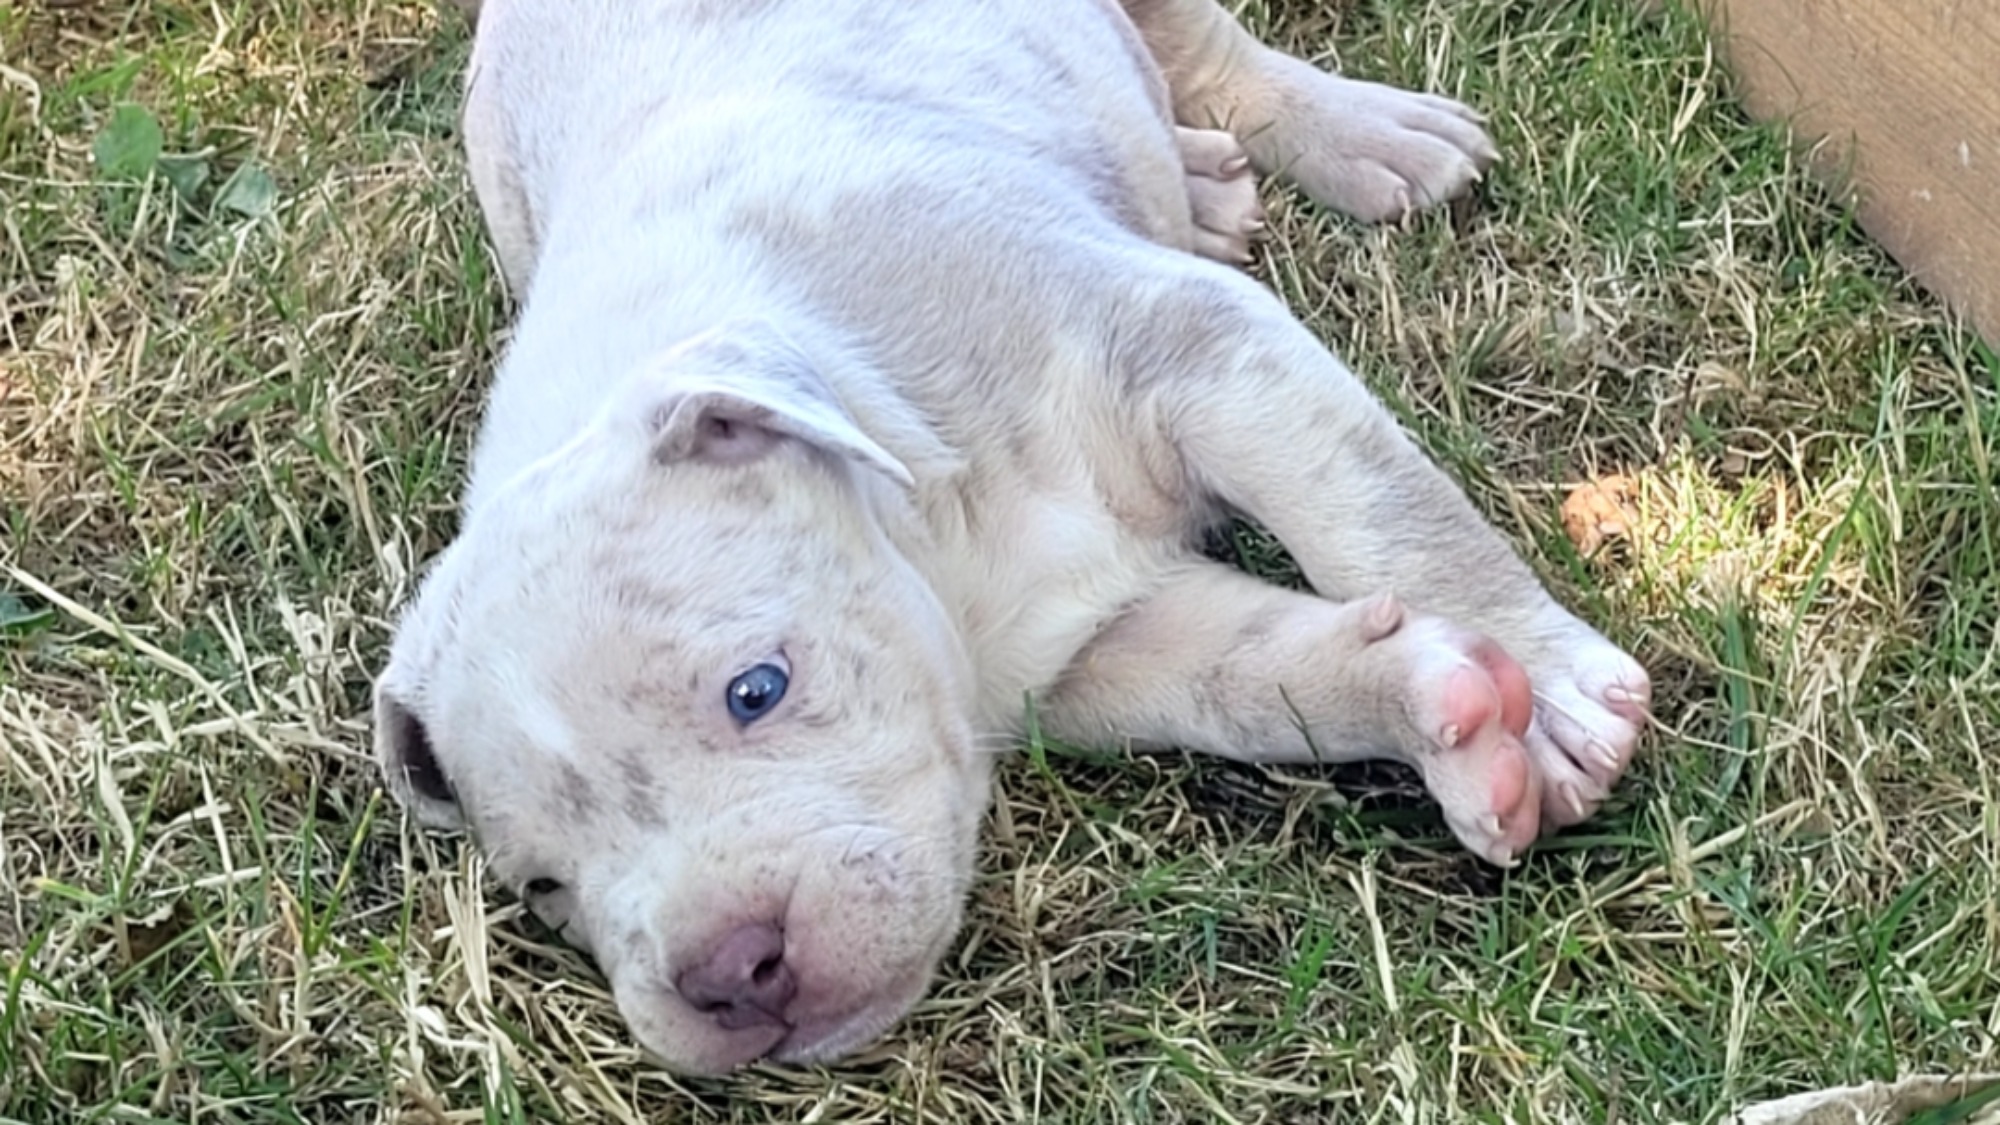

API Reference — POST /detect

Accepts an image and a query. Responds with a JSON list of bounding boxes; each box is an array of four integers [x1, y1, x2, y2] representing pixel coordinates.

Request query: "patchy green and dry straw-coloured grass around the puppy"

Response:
[[0, 0, 2000, 1123]]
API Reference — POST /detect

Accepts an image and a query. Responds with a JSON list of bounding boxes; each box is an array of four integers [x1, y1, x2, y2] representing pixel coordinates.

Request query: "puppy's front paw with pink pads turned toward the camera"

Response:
[[1362, 595, 1542, 867]]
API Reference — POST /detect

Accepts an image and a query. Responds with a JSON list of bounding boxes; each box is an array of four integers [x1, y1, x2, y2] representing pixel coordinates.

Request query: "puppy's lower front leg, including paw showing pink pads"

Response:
[[1040, 563, 1542, 865]]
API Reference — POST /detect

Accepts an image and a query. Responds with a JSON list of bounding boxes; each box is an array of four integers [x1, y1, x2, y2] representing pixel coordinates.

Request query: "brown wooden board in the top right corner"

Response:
[[1698, 0, 2000, 346]]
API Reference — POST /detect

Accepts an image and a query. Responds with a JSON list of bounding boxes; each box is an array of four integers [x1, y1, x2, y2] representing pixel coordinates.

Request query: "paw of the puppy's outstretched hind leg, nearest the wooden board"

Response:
[[1250, 58, 1500, 222]]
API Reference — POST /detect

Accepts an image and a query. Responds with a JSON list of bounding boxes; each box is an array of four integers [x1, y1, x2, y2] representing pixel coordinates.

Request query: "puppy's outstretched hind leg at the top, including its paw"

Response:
[[1122, 0, 1500, 220]]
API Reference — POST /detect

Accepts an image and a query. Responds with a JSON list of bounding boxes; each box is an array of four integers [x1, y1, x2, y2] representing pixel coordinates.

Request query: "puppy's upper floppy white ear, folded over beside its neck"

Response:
[[646, 320, 916, 488]]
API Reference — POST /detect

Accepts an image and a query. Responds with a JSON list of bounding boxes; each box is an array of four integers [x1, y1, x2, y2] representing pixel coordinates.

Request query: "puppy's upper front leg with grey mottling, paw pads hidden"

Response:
[[1126, 266, 1650, 848]]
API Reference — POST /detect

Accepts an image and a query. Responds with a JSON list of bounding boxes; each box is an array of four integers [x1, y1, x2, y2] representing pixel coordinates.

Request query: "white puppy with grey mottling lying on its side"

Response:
[[376, 0, 1648, 1071]]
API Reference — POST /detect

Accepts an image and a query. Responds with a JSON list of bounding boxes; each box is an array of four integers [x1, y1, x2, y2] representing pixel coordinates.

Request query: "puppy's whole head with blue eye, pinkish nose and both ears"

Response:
[[376, 328, 988, 1073]]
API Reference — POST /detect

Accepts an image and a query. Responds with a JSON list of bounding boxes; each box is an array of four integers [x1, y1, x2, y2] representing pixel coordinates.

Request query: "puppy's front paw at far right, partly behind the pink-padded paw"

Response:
[[1524, 619, 1652, 829]]
